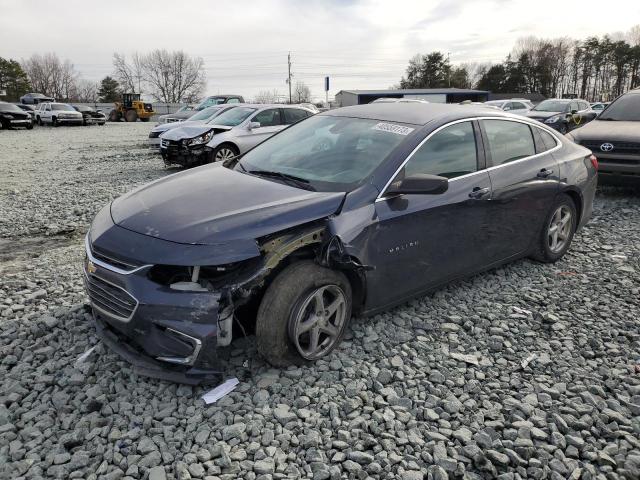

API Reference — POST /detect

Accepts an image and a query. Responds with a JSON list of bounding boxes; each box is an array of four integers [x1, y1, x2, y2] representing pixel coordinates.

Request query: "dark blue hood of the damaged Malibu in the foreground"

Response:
[[111, 164, 345, 245]]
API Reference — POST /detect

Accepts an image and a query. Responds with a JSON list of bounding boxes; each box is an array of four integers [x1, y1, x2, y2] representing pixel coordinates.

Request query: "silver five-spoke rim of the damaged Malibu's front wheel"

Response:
[[289, 285, 347, 360]]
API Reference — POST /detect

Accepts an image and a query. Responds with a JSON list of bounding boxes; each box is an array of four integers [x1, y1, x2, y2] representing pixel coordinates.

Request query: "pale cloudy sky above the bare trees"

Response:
[[0, 0, 640, 100]]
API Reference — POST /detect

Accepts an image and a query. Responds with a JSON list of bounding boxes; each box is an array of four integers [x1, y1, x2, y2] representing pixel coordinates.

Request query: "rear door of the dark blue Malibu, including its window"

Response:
[[481, 119, 560, 263]]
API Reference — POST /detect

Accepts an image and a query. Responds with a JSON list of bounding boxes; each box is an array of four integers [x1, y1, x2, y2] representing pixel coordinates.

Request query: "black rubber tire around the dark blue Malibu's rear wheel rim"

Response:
[[531, 193, 578, 263]]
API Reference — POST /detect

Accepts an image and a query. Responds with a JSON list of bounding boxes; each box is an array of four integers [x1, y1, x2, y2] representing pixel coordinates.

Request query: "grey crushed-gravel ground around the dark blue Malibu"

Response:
[[0, 124, 640, 480]]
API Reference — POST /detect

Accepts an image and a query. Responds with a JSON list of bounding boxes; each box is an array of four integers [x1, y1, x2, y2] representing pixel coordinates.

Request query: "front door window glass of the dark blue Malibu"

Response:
[[404, 122, 478, 178]]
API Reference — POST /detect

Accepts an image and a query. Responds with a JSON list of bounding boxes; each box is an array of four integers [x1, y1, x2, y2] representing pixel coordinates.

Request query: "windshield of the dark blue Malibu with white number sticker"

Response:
[[239, 115, 415, 191]]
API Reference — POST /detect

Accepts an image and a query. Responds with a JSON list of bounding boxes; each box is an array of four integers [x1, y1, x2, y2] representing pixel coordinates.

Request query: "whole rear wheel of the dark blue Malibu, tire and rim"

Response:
[[532, 194, 578, 263]]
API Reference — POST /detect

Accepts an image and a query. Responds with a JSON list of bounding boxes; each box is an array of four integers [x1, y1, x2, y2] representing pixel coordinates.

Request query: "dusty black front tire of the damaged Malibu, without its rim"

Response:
[[256, 260, 352, 367]]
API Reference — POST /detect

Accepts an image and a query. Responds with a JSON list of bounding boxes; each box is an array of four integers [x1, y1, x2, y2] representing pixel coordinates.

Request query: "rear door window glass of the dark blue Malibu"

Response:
[[483, 120, 536, 166]]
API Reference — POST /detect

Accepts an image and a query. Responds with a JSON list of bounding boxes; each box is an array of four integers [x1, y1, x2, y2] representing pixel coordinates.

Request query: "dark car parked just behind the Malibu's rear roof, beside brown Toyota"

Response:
[[526, 98, 597, 133]]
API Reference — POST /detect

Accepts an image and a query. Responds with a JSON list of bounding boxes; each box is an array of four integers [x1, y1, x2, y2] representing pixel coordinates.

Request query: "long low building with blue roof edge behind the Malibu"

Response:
[[335, 88, 489, 107]]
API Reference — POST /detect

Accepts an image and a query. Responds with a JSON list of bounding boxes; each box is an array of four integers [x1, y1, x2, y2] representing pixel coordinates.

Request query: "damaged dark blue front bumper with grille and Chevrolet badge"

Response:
[[84, 236, 232, 384]]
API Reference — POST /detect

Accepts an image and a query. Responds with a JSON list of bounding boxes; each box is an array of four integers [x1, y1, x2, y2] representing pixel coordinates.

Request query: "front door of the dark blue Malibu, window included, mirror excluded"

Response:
[[367, 121, 491, 308]]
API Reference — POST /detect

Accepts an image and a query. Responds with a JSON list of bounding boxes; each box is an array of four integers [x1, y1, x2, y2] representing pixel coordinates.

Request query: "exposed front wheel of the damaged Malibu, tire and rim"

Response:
[[256, 261, 351, 367]]
